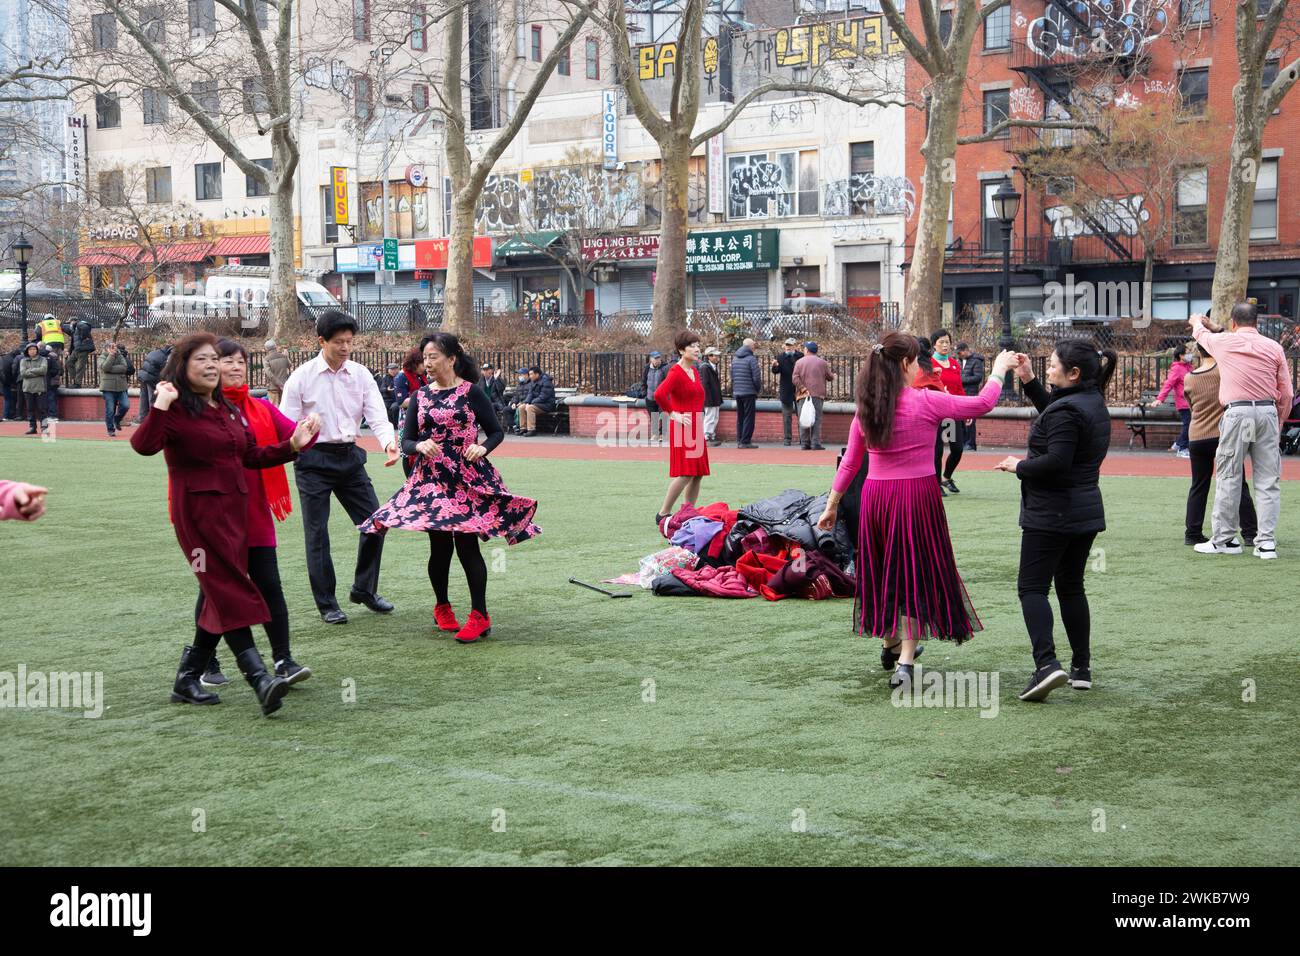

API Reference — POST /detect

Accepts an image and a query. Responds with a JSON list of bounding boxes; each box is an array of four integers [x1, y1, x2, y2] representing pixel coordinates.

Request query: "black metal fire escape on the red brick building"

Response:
[[1006, 0, 1144, 282]]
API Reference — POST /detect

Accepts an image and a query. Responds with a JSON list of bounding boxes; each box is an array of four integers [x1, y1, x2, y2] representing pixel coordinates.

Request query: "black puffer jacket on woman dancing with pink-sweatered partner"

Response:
[[1015, 378, 1110, 535]]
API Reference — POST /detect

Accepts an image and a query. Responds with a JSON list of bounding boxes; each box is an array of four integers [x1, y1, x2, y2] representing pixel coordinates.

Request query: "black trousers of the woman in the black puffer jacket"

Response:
[[1015, 531, 1097, 667]]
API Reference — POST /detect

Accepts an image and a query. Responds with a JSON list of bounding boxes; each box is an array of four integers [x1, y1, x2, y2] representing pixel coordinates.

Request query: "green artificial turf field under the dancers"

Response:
[[0, 438, 1300, 865]]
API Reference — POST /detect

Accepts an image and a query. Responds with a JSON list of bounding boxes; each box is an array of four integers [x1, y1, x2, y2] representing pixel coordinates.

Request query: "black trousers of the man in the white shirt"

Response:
[[294, 445, 384, 614]]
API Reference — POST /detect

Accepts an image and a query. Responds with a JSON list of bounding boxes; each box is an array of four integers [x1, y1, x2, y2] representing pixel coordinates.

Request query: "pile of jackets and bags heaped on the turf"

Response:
[[642, 489, 855, 601]]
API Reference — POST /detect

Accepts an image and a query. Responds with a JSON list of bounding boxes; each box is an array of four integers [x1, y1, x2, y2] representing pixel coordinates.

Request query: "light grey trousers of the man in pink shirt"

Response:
[[1210, 405, 1282, 548]]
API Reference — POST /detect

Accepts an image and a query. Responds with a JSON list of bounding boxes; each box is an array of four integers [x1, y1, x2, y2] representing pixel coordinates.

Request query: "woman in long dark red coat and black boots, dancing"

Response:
[[131, 332, 320, 714]]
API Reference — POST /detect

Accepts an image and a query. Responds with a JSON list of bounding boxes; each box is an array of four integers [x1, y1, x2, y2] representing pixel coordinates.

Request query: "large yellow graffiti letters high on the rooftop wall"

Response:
[[637, 13, 904, 79]]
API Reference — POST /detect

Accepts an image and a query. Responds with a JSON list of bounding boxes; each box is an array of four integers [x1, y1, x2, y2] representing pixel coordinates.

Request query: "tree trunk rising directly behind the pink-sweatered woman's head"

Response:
[[902, 75, 967, 336]]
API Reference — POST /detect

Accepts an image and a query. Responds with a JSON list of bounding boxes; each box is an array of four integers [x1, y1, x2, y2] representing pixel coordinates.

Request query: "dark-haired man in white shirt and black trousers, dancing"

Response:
[[280, 310, 398, 624]]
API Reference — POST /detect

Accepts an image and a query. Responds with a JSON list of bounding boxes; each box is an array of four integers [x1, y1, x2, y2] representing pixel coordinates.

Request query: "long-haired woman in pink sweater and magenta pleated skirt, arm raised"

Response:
[[818, 332, 1015, 687]]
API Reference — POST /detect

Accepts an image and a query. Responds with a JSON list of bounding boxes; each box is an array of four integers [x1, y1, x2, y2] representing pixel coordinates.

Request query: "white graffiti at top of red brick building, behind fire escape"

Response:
[[1017, 0, 1169, 59]]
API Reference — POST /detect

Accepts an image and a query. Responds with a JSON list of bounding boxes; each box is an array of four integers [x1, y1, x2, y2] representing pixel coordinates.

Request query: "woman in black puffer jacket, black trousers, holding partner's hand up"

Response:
[[997, 338, 1115, 701]]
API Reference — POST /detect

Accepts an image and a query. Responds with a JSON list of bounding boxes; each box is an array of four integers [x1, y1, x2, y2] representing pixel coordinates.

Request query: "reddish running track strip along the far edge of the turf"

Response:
[[0, 421, 1300, 480]]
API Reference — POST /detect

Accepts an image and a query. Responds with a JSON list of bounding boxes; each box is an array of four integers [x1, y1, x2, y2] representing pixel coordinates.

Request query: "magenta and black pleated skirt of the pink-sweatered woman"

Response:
[[854, 475, 984, 644]]
